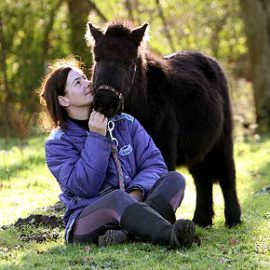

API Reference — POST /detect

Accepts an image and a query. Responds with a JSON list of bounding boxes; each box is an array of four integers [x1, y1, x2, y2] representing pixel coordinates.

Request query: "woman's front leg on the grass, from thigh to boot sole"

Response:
[[73, 185, 198, 248]]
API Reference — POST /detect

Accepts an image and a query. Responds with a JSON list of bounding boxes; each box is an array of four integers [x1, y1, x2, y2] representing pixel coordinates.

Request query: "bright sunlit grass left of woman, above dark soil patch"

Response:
[[0, 137, 59, 226]]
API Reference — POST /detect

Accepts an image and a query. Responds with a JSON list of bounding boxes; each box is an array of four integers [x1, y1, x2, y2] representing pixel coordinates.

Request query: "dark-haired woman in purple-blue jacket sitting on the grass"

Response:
[[40, 58, 198, 248]]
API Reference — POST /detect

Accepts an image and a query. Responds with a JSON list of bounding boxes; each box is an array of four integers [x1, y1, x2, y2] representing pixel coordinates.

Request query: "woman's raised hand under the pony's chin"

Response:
[[88, 111, 108, 136]]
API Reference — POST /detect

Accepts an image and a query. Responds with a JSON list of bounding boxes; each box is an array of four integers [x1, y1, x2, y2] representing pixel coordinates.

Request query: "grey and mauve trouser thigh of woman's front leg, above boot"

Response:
[[72, 190, 136, 243]]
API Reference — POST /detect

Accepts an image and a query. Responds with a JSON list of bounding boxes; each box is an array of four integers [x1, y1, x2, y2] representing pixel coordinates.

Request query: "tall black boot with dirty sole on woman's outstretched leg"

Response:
[[120, 202, 197, 248]]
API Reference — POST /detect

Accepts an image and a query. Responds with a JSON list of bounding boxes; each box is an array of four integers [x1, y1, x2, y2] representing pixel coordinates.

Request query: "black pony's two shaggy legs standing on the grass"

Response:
[[190, 140, 241, 227]]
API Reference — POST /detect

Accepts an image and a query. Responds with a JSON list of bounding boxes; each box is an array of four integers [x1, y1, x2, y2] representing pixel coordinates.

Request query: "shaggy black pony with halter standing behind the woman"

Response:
[[87, 23, 241, 227]]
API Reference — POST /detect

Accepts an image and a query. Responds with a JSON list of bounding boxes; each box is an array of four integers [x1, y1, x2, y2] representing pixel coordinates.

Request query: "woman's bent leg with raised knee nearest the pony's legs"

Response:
[[145, 172, 186, 224]]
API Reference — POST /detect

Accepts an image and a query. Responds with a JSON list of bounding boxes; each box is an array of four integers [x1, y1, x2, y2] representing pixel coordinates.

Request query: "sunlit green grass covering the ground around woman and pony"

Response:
[[0, 136, 270, 269]]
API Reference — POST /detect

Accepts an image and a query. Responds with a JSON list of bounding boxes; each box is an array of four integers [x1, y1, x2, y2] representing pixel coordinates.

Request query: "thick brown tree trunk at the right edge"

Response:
[[240, 0, 270, 132]]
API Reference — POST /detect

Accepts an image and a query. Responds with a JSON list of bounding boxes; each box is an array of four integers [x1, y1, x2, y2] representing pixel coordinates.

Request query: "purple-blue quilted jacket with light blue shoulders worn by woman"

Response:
[[45, 113, 167, 242]]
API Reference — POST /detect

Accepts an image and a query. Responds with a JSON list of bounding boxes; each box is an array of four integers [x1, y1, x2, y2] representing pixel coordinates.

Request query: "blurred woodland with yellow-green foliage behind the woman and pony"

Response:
[[0, 0, 270, 140]]
